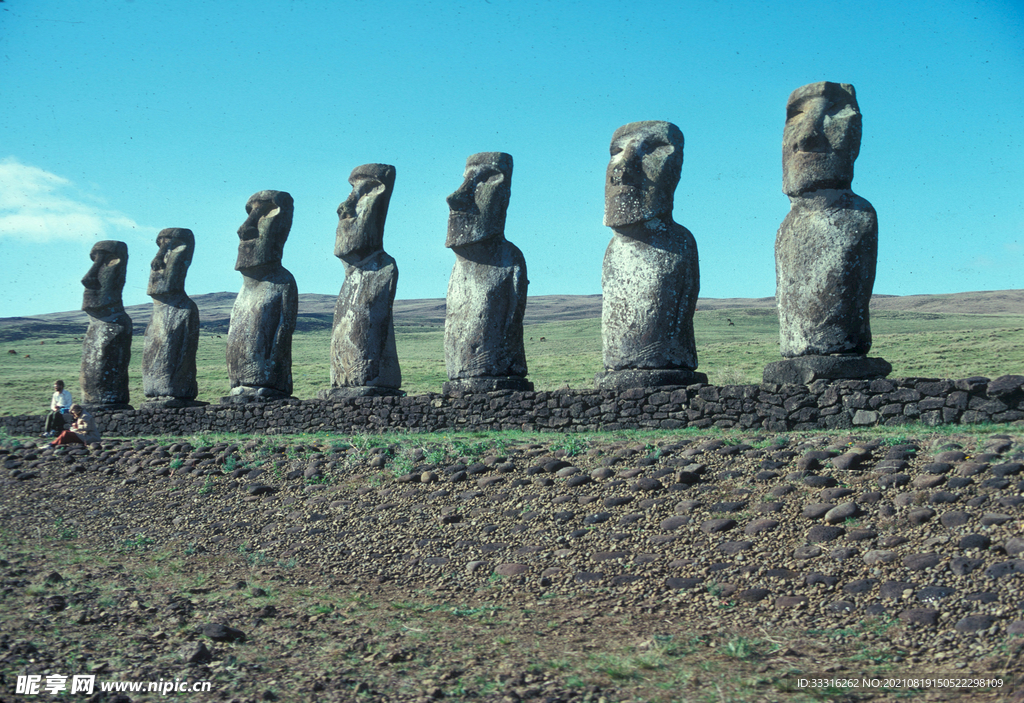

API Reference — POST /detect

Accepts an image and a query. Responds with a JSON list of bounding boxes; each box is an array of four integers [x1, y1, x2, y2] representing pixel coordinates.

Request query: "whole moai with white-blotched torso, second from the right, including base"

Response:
[[595, 117, 708, 389]]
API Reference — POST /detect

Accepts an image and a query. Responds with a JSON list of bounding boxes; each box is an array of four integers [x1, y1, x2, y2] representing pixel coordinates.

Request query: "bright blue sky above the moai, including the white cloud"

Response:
[[0, 0, 1024, 316]]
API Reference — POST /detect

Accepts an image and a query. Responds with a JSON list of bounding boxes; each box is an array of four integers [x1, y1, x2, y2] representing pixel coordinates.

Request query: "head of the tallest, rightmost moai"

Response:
[[782, 81, 861, 196]]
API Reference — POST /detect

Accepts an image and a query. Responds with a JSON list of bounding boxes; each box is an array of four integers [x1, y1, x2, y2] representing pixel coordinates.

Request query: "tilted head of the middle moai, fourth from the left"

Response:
[[334, 164, 395, 259]]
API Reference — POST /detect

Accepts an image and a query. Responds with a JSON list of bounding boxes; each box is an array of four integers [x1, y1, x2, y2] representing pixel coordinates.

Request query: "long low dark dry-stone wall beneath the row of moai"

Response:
[[0, 376, 1024, 437]]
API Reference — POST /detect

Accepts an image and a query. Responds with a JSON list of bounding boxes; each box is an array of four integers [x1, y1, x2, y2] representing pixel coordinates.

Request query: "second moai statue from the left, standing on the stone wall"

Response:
[[142, 227, 208, 407]]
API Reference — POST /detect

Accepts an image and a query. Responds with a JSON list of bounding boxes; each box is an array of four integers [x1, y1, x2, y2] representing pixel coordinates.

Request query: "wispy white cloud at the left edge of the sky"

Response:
[[0, 157, 146, 243]]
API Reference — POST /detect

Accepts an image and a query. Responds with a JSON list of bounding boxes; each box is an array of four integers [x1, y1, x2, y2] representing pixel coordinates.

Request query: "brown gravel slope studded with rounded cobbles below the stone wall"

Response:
[[0, 432, 1024, 701]]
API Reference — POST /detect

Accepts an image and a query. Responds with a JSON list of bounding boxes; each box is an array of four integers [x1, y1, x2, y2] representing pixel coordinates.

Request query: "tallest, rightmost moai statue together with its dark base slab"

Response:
[[764, 82, 892, 384]]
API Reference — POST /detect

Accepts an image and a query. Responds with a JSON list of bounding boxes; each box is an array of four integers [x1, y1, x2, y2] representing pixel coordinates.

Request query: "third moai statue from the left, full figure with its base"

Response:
[[221, 190, 299, 403]]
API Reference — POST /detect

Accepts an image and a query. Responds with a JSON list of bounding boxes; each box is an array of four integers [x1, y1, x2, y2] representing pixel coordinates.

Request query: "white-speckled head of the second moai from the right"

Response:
[[604, 122, 683, 227]]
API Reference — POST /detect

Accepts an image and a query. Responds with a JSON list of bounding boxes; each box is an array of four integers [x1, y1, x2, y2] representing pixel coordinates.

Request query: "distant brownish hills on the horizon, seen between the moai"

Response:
[[0, 290, 1024, 340]]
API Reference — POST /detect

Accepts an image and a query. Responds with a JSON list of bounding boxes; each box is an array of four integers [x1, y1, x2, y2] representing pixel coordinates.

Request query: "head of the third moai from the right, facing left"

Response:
[[444, 151, 512, 249]]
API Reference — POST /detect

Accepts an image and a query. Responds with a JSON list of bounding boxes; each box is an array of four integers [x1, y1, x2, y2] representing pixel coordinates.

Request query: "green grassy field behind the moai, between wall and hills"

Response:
[[0, 308, 1024, 414]]
